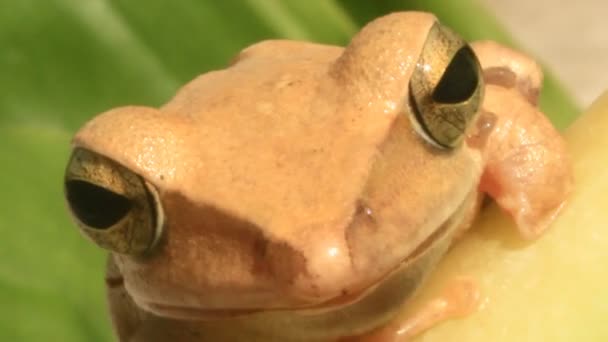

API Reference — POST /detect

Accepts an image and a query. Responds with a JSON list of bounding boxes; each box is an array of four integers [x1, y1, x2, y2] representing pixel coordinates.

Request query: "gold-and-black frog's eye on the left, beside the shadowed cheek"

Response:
[[65, 148, 164, 255]]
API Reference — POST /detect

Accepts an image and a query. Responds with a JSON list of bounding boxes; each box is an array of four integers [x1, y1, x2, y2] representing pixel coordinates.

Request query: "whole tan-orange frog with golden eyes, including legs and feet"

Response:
[[64, 12, 573, 342]]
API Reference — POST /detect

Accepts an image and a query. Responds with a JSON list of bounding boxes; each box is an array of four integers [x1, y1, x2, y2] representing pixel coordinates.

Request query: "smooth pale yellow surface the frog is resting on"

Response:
[[416, 92, 608, 342]]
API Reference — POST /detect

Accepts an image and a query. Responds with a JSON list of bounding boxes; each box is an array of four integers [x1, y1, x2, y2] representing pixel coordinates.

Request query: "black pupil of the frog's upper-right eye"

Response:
[[433, 46, 479, 103]]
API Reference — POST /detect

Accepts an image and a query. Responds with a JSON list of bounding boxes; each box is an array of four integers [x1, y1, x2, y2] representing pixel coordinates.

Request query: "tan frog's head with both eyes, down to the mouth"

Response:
[[65, 13, 483, 316]]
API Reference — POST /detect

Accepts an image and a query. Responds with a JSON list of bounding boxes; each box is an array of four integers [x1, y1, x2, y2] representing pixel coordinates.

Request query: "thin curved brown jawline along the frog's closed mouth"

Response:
[[138, 189, 478, 321]]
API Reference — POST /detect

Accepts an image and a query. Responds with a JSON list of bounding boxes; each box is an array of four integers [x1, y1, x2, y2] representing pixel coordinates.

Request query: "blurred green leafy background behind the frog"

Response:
[[0, 0, 577, 342]]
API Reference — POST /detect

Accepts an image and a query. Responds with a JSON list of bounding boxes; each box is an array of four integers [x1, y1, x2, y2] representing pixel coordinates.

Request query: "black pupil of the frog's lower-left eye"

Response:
[[65, 180, 131, 229]]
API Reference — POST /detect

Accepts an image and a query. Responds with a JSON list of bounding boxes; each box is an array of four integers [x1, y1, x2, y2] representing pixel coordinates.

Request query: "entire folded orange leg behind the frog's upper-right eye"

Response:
[[472, 42, 573, 238]]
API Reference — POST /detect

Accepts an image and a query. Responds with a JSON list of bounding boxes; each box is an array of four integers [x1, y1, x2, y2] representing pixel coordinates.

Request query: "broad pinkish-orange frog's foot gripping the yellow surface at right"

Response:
[[480, 85, 572, 239]]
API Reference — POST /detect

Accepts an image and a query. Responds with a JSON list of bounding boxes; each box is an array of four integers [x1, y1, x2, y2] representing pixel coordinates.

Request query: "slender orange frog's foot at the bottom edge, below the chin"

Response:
[[340, 278, 479, 342]]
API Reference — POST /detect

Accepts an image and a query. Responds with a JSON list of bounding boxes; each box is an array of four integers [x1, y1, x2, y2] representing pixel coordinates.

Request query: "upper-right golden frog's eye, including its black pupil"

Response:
[[409, 23, 483, 148]]
